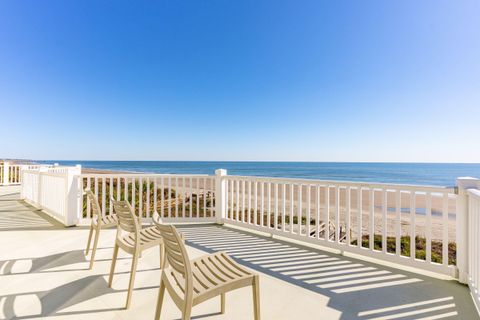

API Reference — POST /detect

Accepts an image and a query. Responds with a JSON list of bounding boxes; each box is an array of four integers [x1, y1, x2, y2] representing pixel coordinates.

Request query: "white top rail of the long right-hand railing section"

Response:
[[223, 175, 455, 193]]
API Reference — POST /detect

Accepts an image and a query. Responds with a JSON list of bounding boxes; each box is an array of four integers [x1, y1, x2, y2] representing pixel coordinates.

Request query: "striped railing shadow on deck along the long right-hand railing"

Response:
[[179, 225, 477, 320]]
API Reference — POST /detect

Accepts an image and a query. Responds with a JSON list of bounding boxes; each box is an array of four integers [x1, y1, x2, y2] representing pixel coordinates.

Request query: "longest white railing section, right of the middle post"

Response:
[[223, 176, 456, 276]]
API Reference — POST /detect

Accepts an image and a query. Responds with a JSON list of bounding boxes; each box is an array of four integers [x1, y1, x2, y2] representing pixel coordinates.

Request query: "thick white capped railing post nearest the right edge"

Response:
[[456, 177, 480, 283]]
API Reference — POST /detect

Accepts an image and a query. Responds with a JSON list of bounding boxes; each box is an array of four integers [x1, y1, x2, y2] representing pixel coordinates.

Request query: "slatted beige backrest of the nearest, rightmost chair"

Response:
[[154, 221, 193, 278]]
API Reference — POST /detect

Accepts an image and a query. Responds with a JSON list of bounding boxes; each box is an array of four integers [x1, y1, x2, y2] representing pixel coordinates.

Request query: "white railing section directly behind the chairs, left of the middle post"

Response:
[[81, 174, 215, 222]]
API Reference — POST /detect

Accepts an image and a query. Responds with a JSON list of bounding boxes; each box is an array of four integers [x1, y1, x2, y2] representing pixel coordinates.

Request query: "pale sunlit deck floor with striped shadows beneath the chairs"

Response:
[[0, 187, 479, 320]]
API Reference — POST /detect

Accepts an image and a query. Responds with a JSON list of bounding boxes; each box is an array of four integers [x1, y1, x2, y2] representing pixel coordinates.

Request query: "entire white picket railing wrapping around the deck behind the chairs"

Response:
[[14, 167, 480, 305]]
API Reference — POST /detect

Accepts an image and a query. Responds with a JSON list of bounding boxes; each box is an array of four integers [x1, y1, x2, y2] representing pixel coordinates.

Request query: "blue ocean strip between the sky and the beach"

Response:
[[38, 160, 480, 187]]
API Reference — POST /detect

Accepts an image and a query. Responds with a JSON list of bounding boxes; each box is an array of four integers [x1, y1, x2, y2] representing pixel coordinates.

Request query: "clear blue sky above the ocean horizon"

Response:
[[0, 0, 480, 162]]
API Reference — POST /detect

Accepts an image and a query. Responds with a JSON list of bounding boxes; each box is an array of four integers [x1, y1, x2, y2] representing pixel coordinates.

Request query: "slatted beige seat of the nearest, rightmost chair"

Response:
[[165, 252, 256, 305]]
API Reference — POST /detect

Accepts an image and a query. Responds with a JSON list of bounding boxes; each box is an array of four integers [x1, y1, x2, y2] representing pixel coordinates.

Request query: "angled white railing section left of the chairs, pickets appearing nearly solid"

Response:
[[21, 167, 81, 226]]
